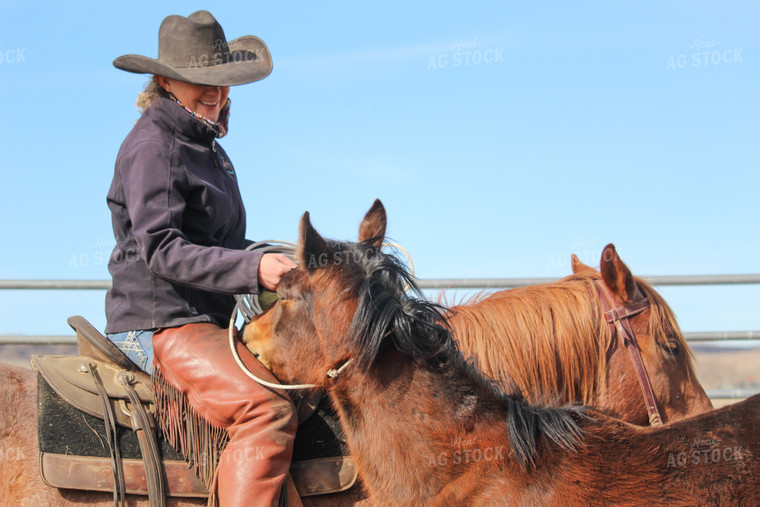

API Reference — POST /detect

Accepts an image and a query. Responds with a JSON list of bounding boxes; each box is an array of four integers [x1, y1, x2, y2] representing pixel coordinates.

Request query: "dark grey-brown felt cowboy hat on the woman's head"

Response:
[[113, 11, 272, 86]]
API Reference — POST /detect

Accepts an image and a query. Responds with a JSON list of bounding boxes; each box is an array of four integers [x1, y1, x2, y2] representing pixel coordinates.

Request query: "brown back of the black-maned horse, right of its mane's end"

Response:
[[548, 402, 760, 505]]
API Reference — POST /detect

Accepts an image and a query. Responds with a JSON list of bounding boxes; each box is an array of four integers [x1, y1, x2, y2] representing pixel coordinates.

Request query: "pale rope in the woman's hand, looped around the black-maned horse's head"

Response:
[[228, 240, 414, 391]]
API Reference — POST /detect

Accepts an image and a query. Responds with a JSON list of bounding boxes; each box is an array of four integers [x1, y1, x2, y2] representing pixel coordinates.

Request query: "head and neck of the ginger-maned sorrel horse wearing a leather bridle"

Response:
[[449, 244, 712, 425]]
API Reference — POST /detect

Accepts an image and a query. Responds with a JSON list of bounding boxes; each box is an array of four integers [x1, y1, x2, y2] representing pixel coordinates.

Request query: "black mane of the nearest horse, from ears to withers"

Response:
[[331, 241, 590, 467]]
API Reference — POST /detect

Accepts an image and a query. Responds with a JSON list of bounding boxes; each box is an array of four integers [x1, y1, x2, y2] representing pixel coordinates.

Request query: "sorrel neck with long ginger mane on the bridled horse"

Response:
[[450, 279, 609, 405]]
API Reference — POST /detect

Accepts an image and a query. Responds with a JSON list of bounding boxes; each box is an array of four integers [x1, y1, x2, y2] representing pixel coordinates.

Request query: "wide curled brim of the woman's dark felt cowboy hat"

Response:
[[113, 35, 272, 86]]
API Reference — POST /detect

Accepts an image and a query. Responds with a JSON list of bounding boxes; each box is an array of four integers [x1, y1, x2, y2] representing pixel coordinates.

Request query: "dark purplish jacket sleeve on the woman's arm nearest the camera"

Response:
[[116, 141, 261, 294]]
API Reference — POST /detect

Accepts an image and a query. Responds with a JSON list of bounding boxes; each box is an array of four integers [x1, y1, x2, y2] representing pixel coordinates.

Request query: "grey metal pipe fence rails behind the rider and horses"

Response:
[[0, 274, 760, 399]]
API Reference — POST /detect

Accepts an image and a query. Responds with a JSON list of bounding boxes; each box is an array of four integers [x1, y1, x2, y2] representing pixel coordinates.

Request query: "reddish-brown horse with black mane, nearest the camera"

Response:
[[246, 203, 760, 506]]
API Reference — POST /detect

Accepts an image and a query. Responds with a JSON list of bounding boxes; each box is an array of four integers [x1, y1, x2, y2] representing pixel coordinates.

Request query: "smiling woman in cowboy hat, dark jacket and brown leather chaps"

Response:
[[106, 11, 297, 506]]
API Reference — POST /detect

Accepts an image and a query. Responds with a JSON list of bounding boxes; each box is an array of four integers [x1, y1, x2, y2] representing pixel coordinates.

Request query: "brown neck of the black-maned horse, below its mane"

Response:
[[328, 351, 507, 505]]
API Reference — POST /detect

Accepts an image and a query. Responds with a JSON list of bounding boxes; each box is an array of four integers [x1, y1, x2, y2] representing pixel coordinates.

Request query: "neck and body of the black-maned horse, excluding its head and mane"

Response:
[[342, 357, 760, 506]]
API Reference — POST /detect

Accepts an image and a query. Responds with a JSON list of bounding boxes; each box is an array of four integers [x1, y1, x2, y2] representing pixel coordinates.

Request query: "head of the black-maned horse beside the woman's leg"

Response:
[[243, 200, 450, 387]]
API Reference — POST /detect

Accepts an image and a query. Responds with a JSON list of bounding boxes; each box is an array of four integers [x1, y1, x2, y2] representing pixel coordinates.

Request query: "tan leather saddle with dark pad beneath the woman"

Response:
[[31, 316, 357, 506]]
